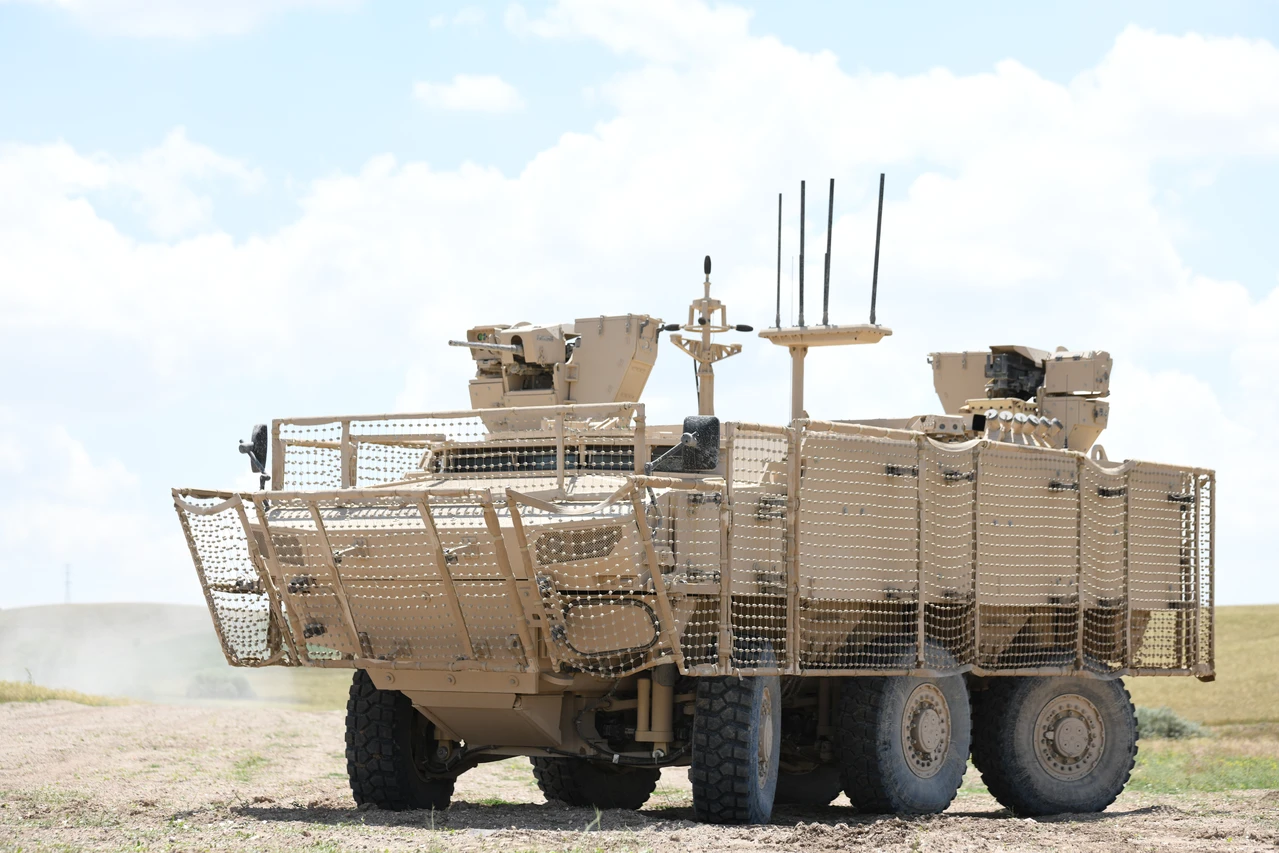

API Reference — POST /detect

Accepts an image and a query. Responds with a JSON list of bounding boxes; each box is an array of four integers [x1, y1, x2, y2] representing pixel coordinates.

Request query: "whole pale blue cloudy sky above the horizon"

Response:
[[0, 0, 1279, 607]]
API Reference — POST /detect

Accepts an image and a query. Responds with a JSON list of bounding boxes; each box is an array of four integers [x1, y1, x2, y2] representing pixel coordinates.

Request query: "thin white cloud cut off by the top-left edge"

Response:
[[0, 0, 361, 38]]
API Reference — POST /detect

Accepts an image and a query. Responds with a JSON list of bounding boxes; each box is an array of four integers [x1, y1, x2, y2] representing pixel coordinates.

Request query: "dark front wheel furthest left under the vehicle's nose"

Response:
[[347, 669, 455, 811]]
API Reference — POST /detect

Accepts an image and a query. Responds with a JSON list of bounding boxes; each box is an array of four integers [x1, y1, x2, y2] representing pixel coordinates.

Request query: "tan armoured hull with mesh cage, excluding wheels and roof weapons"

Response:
[[174, 404, 1214, 752]]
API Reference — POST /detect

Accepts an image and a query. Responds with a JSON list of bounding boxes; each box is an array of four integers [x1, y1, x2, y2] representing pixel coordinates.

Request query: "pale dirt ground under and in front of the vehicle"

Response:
[[0, 702, 1279, 853]]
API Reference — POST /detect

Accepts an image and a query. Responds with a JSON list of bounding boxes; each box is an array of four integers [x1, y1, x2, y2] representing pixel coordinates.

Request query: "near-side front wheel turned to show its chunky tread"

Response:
[[688, 648, 781, 824]]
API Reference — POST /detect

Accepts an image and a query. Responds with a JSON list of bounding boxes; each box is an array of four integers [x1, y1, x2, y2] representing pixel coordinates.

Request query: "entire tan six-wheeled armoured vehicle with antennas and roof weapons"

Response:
[[173, 175, 1215, 822]]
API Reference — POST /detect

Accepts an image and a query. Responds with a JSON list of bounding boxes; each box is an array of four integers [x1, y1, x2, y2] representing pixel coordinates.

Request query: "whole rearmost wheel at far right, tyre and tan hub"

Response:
[[972, 677, 1137, 816]]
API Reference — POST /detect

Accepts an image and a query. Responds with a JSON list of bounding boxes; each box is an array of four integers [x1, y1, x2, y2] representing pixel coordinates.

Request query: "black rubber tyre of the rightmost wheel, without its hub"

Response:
[[972, 677, 1137, 817]]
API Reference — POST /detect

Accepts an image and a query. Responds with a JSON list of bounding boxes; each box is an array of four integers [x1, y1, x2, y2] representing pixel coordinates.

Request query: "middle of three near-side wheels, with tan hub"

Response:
[[835, 650, 972, 815]]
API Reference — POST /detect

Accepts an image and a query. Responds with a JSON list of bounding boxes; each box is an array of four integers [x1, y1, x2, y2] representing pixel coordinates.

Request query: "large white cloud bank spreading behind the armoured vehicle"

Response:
[[0, 3, 1279, 601]]
